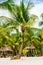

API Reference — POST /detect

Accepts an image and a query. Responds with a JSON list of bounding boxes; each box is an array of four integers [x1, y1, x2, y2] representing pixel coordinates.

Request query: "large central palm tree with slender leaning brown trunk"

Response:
[[0, 0, 37, 57]]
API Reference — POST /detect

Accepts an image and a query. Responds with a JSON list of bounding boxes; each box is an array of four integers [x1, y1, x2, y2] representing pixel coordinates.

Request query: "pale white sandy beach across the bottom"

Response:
[[0, 57, 43, 65]]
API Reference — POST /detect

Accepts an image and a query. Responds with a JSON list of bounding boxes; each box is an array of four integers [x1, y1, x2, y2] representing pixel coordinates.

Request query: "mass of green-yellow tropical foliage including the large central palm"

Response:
[[0, 0, 43, 58]]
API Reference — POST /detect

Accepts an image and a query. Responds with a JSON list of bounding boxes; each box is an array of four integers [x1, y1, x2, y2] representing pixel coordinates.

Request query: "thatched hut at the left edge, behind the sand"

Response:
[[0, 46, 13, 57]]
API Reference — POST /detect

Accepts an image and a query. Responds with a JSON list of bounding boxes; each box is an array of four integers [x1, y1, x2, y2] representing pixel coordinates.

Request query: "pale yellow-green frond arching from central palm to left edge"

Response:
[[0, 16, 18, 32]]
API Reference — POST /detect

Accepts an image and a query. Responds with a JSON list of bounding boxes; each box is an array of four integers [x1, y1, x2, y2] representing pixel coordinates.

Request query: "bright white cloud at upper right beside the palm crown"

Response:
[[30, 3, 43, 18]]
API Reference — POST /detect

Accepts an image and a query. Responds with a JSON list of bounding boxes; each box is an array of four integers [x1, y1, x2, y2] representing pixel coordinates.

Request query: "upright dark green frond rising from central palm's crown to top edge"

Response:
[[20, 0, 29, 22]]
